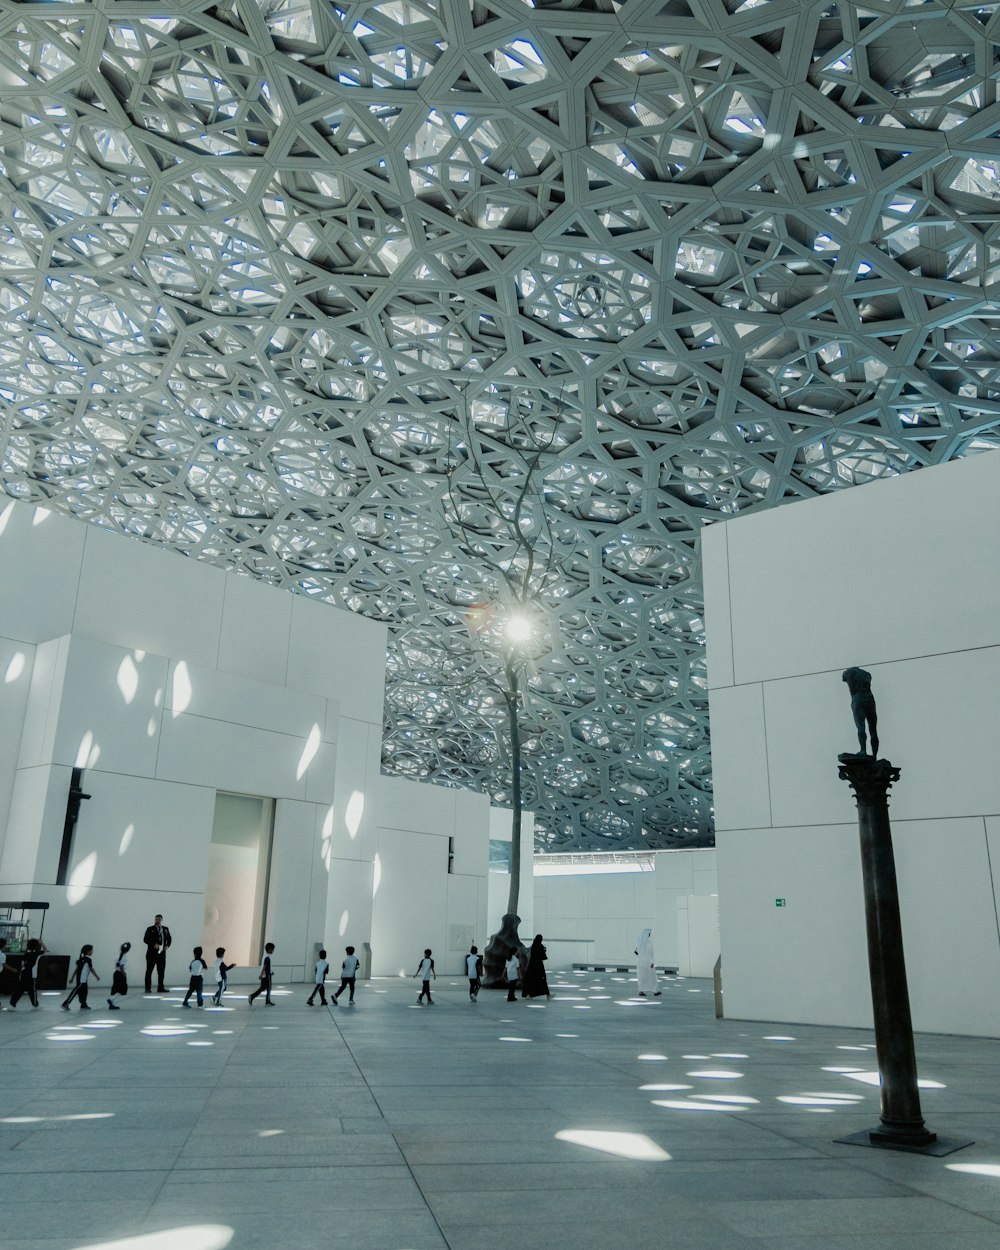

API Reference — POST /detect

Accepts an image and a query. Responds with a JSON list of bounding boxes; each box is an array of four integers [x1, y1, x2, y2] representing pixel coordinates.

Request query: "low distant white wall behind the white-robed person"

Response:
[[535, 850, 719, 976]]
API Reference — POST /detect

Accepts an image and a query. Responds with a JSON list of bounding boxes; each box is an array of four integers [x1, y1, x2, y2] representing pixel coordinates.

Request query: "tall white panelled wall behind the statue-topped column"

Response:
[[703, 453, 1000, 1036]]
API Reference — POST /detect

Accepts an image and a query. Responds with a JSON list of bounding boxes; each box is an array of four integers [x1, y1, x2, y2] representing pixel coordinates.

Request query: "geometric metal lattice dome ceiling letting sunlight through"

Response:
[[0, 0, 1000, 850]]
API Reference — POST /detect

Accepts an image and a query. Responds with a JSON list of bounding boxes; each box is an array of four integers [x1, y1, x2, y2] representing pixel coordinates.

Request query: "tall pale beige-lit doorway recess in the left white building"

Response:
[[201, 790, 274, 964]]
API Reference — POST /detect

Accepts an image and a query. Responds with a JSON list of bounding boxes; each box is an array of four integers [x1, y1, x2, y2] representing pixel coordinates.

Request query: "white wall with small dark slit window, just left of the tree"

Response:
[[371, 778, 490, 976]]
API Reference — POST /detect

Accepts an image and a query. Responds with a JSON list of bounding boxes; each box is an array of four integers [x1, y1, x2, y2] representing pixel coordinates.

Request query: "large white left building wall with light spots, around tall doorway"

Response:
[[0, 503, 386, 979]]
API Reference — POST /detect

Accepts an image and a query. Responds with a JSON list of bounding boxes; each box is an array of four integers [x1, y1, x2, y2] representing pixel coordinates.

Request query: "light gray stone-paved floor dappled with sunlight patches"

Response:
[[0, 974, 1000, 1250]]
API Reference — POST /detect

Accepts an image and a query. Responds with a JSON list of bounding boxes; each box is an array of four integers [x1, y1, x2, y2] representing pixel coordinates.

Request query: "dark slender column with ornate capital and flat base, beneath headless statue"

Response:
[[838, 754, 971, 1155]]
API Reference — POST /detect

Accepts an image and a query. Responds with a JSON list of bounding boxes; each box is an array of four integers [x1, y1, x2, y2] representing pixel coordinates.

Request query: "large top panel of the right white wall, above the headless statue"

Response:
[[725, 451, 1000, 684]]
